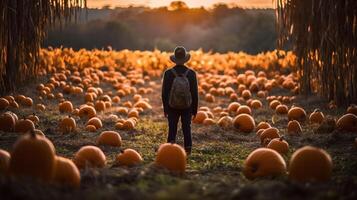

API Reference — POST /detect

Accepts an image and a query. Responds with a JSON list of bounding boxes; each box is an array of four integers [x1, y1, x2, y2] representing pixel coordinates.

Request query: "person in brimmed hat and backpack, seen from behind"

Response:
[[162, 46, 198, 155]]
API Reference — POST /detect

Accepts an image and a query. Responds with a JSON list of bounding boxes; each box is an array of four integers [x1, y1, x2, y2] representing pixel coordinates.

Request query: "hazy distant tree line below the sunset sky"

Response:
[[45, 6, 276, 54]]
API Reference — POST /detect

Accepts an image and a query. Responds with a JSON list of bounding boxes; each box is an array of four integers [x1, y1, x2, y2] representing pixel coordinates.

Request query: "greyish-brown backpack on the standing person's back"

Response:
[[169, 68, 192, 109]]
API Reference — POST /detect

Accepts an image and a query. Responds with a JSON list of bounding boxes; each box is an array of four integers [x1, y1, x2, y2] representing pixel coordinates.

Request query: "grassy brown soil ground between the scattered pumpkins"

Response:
[[0, 73, 357, 200]]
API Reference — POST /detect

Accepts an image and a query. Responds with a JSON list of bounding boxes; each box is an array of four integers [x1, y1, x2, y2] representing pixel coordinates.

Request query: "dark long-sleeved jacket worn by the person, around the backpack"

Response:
[[161, 65, 198, 115]]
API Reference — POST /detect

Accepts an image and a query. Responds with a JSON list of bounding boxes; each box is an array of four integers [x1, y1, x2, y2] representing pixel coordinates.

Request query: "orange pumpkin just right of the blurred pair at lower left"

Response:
[[74, 145, 107, 169]]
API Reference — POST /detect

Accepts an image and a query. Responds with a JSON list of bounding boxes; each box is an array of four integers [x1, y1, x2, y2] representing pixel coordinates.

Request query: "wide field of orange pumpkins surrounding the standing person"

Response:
[[0, 27, 350, 199]]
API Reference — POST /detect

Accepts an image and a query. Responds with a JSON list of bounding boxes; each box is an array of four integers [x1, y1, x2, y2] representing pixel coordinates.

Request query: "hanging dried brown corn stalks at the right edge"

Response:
[[276, 0, 357, 104]]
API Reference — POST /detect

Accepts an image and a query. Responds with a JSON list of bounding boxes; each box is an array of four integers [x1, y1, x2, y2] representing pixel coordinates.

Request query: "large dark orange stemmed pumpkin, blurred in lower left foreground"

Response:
[[9, 131, 55, 181]]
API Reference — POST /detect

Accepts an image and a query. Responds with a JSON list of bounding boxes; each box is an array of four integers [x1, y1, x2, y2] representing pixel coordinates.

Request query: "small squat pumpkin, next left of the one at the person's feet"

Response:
[[116, 149, 143, 167]]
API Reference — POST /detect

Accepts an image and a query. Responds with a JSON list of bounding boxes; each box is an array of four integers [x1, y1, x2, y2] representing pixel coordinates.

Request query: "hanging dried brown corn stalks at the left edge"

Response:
[[0, 0, 86, 93]]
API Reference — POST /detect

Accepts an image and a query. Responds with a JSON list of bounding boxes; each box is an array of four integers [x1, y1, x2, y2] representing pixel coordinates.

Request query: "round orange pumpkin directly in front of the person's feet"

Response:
[[155, 143, 186, 173]]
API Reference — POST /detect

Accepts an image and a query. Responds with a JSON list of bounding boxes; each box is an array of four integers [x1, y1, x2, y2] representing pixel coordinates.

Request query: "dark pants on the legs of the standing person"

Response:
[[167, 111, 192, 151]]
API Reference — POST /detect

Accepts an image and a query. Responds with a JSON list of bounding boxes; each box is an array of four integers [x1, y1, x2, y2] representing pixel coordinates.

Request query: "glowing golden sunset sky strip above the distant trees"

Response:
[[87, 0, 274, 8]]
